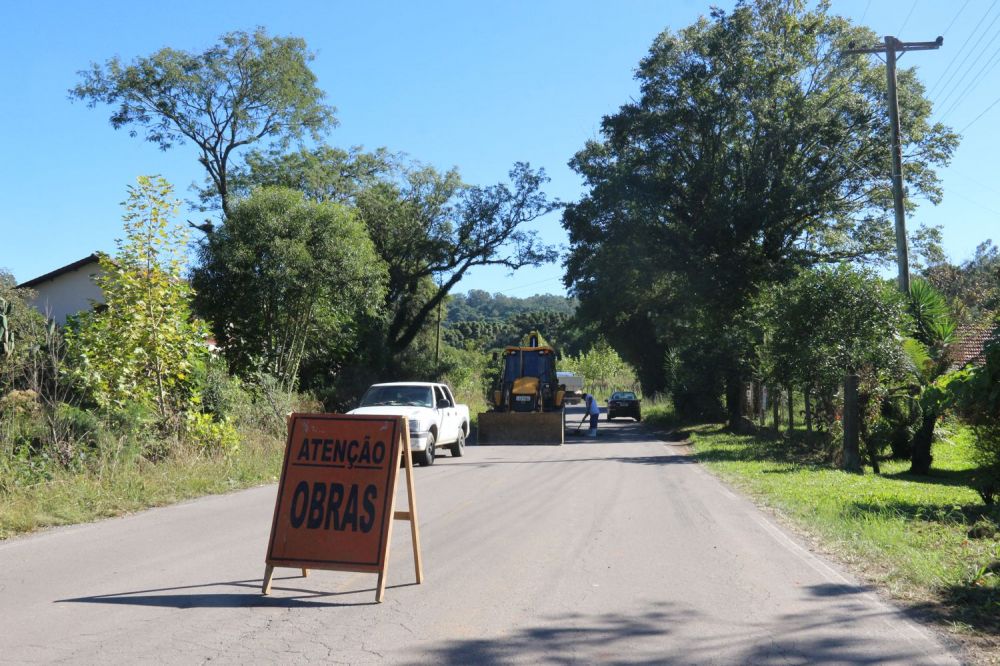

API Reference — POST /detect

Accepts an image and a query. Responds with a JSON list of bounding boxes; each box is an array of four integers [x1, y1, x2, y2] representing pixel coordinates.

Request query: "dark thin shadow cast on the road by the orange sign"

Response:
[[55, 576, 416, 608]]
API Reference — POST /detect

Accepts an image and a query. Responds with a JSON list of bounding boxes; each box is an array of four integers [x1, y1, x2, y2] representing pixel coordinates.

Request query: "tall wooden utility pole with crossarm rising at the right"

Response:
[[843, 35, 944, 294]]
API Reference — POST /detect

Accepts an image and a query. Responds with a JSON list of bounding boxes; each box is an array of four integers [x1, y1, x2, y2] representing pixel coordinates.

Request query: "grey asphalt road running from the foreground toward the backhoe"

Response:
[[0, 408, 957, 664]]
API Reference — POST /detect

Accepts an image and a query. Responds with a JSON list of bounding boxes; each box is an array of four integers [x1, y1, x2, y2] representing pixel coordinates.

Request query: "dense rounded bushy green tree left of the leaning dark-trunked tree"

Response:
[[192, 187, 386, 388]]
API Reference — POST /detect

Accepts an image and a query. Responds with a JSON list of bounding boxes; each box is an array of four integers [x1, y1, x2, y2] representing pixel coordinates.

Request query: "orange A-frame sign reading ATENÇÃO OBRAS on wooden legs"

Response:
[[262, 414, 423, 601]]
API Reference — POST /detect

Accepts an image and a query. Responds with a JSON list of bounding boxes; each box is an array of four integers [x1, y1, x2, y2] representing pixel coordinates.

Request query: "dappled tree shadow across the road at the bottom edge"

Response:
[[400, 600, 928, 665]]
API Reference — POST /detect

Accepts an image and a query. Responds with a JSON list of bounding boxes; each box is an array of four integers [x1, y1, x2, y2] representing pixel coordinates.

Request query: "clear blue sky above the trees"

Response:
[[0, 0, 1000, 296]]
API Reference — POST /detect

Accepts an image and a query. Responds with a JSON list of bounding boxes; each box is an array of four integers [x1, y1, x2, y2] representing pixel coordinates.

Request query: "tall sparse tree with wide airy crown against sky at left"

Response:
[[69, 28, 334, 216]]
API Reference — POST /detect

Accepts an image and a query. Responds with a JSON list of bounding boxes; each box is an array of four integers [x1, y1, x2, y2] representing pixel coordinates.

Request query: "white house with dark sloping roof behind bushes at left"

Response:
[[17, 252, 104, 325]]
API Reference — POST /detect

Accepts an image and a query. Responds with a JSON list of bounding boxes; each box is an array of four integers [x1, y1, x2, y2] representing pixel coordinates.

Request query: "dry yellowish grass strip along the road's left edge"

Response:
[[0, 434, 284, 539]]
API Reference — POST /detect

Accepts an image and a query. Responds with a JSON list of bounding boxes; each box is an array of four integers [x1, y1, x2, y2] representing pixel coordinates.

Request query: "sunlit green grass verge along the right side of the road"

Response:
[[680, 417, 1000, 663]]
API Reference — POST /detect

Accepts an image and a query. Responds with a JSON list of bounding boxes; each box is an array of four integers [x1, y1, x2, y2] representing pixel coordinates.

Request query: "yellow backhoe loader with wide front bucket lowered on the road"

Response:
[[479, 331, 566, 444]]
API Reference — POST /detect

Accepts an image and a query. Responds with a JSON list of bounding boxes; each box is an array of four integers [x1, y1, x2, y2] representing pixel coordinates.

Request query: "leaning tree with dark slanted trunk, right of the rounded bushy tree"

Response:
[[240, 146, 558, 362]]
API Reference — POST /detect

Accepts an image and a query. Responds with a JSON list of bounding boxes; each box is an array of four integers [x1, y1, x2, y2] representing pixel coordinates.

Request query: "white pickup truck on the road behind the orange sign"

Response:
[[348, 382, 469, 467]]
